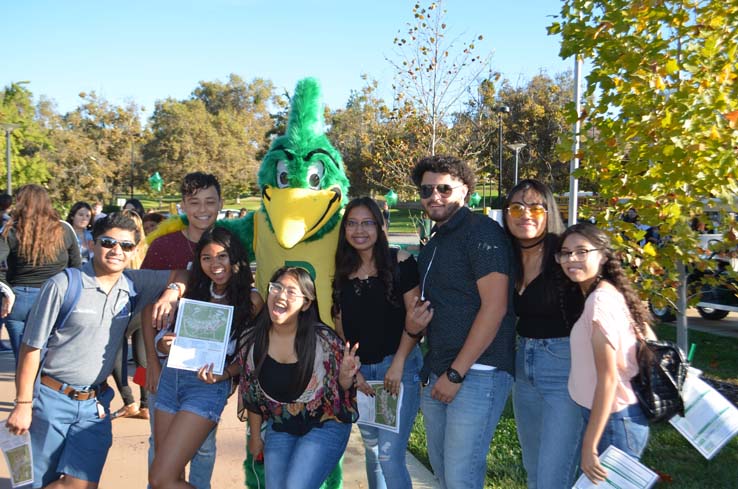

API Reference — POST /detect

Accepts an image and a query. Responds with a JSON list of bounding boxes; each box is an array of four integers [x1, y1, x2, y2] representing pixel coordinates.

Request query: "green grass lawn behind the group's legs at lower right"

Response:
[[408, 325, 738, 489]]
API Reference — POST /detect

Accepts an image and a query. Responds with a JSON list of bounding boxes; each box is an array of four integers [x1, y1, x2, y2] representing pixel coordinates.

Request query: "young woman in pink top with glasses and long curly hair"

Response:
[[555, 224, 651, 482]]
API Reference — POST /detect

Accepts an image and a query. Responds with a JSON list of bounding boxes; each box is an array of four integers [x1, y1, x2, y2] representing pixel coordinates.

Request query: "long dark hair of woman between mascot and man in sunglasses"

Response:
[[331, 197, 397, 317]]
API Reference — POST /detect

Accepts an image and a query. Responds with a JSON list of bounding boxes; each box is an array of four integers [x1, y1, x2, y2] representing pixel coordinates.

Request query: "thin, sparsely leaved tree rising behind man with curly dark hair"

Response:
[[388, 0, 491, 154]]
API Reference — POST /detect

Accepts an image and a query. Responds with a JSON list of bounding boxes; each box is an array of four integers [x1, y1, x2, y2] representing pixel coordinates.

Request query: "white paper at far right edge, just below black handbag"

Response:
[[669, 369, 738, 460]]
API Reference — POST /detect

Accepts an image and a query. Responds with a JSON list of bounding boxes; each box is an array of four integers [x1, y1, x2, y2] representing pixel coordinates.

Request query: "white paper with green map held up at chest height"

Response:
[[167, 299, 233, 375]]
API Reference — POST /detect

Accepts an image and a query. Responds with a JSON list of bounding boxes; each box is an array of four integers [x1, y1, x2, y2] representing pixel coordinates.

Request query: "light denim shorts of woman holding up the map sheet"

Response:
[[156, 365, 231, 423]]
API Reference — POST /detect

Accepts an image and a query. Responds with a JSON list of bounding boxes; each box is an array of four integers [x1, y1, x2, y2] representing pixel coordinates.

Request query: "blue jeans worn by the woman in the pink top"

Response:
[[581, 403, 648, 459]]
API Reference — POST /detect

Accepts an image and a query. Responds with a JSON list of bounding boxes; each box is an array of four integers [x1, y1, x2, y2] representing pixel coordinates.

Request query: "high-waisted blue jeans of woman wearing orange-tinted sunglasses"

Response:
[[513, 337, 584, 489]]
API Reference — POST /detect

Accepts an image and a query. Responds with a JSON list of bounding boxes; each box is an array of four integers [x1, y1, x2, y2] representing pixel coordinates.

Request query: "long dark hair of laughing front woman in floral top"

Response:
[[244, 267, 325, 392]]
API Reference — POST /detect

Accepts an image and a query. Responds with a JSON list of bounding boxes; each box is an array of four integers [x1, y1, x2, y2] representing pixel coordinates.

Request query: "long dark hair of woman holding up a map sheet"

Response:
[[185, 227, 254, 341]]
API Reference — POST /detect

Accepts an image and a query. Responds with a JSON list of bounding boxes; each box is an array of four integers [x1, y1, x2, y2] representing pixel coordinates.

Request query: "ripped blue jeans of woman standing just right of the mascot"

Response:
[[359, 346, 423, 489]]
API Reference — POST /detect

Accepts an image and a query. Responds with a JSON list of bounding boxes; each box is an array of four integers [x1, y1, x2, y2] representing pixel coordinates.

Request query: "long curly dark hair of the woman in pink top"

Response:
[[559, 222, 653, 339]]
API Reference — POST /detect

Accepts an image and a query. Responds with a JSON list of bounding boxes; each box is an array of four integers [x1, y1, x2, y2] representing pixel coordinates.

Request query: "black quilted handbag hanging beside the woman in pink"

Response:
[[631, 340, 689, 423]]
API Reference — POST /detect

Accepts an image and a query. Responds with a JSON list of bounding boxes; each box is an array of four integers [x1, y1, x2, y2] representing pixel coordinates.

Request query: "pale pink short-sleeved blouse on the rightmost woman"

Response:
[[569, 285, 638, 413]]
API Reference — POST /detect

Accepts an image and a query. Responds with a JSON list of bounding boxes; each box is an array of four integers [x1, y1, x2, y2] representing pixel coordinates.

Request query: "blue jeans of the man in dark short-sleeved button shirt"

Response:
[[420, 369, 513, 489]]
